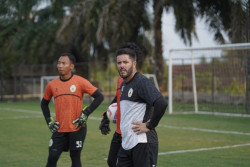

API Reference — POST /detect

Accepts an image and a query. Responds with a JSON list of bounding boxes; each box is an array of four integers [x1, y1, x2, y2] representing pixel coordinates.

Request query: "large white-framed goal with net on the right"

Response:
[[168, 43, 250, 115]]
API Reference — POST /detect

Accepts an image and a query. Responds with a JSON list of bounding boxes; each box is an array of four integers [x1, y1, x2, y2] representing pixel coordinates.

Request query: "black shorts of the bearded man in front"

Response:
[[117, 143, 158, 167]]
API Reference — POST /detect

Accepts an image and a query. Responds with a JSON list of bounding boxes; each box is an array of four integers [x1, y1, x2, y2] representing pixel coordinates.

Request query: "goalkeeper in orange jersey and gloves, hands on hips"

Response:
[[41, 53, 103, 167]]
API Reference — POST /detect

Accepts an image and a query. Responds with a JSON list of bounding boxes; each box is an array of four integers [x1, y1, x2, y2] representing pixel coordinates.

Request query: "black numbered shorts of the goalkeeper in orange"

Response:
[[49, 126, 87, 151]]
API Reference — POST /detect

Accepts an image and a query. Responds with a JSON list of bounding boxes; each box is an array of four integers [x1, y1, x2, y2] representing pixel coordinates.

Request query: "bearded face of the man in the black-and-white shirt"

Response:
[[116, 54, 136, 80]]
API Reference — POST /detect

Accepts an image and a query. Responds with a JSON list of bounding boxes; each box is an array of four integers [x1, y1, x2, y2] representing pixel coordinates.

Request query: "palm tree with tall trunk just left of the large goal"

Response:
[[97, 0, 196, 88]]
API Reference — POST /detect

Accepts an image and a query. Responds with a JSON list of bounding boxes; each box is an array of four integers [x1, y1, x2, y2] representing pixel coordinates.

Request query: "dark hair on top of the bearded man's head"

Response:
[[116, 42, 142, 61]]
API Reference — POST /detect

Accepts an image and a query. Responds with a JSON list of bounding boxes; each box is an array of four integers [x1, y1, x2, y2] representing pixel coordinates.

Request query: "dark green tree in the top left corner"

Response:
[[0, 0, 80, 64]]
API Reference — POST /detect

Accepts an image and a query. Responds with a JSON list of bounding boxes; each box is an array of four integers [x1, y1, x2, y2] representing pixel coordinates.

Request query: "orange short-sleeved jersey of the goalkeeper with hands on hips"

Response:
[[43, 75, 97, 132]]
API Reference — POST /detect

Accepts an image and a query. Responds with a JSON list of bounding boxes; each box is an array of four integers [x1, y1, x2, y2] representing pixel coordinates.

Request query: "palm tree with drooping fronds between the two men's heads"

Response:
[[56, 0, 108, 81]]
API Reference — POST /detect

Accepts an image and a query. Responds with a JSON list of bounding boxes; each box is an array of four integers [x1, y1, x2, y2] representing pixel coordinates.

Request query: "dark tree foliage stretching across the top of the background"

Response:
[[0, 0, 249, 85]]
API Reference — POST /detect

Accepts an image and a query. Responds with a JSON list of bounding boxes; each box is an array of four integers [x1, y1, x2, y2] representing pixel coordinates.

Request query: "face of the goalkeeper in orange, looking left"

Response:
[[57, 56, 74, 76]]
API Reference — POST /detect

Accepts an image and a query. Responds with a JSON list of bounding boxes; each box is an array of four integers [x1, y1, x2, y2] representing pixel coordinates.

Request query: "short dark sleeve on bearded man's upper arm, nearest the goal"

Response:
[[138, 78, 161, 105]]
